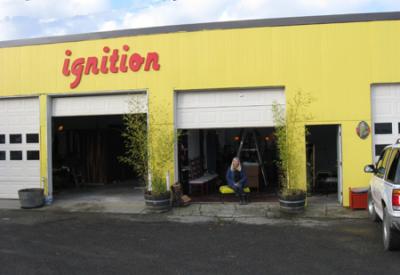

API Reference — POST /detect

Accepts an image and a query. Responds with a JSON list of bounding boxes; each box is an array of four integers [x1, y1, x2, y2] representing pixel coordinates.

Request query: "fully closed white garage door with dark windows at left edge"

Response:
[[0, 98, 40, 198]]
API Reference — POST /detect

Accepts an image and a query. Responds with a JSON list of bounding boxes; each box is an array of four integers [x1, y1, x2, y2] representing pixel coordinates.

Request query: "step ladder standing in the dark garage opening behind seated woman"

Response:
[[236, 129, 268, 186]]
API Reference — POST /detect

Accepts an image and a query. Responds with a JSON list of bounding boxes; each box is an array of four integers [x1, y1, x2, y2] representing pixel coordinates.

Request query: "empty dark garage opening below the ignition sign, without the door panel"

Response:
[[52, 115, 139, 195]]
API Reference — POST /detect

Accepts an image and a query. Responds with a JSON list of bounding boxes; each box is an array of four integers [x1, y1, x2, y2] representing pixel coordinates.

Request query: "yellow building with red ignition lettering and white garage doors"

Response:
[[0, 12, 400, 206]]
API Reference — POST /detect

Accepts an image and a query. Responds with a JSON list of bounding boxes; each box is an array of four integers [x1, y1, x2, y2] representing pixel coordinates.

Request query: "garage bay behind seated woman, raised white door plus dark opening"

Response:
[[175, 87, 286, 201]]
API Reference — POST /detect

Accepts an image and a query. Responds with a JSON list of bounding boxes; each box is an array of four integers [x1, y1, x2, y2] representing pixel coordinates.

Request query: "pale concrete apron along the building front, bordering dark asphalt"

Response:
[[0, 194, 368, 224]]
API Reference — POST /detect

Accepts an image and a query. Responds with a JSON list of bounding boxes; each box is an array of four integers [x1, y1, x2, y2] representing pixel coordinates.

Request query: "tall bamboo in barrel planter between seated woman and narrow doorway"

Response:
[[272, 92, 312, 213]]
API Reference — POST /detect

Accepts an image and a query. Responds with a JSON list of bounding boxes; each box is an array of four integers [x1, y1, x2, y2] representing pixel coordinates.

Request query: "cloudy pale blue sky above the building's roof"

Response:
[[0, 0, 400, 40]]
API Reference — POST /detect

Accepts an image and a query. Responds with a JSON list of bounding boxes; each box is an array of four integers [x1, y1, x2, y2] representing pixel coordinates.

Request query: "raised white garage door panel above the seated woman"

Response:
[[176, 88, 285, 129]]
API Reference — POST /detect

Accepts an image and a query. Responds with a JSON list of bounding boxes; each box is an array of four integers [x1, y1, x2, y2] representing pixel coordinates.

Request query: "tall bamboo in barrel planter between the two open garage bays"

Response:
[[120, 96, 177, 212]]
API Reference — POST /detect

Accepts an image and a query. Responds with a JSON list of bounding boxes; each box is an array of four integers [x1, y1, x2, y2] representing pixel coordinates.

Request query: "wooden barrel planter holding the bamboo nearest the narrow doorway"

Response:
[[279, 189, 306, 213]]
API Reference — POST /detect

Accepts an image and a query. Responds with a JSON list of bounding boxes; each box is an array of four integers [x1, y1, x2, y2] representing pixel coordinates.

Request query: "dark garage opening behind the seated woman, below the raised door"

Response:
[[178, 127, 279, 202]]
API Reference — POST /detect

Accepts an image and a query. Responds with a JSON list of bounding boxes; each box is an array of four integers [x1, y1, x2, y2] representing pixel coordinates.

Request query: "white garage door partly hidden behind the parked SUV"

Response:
[[372, 84, 400, 156]]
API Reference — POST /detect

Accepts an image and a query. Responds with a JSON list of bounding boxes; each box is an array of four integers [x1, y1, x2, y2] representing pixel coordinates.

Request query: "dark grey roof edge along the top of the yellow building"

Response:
[[0, 11, 400, 48]]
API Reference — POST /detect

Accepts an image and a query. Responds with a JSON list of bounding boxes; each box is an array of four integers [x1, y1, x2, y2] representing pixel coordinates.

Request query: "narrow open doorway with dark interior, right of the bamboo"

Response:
[[306, 125, 342, 201]]
